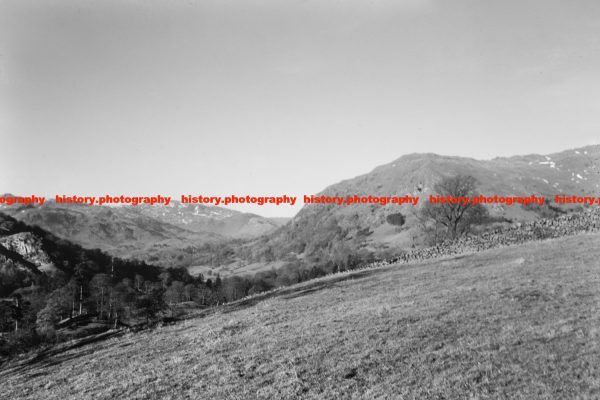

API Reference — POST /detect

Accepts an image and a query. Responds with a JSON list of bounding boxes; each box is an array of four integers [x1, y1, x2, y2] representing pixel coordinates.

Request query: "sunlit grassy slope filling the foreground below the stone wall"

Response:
[[0, 235, 600, 399]]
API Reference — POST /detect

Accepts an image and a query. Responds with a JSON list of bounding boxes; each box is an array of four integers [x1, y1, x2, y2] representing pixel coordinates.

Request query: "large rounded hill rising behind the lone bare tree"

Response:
[[223, 146, 600, 271]]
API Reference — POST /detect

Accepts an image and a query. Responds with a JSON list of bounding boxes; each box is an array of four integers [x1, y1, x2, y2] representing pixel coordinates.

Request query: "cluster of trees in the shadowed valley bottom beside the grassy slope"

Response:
[[0, 267, 230, 355]]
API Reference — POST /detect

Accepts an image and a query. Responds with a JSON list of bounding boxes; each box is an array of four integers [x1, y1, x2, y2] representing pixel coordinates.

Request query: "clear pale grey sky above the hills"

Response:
[[0, 0, 600, 217]]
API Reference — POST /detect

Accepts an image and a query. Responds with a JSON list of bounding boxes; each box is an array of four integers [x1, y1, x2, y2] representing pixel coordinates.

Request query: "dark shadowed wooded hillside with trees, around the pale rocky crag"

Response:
[[0, 214, 238, 356]]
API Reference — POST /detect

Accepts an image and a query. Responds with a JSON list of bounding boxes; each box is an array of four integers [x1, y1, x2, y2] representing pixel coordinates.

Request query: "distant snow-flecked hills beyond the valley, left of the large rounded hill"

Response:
[[2, 200, 281, 267]]
